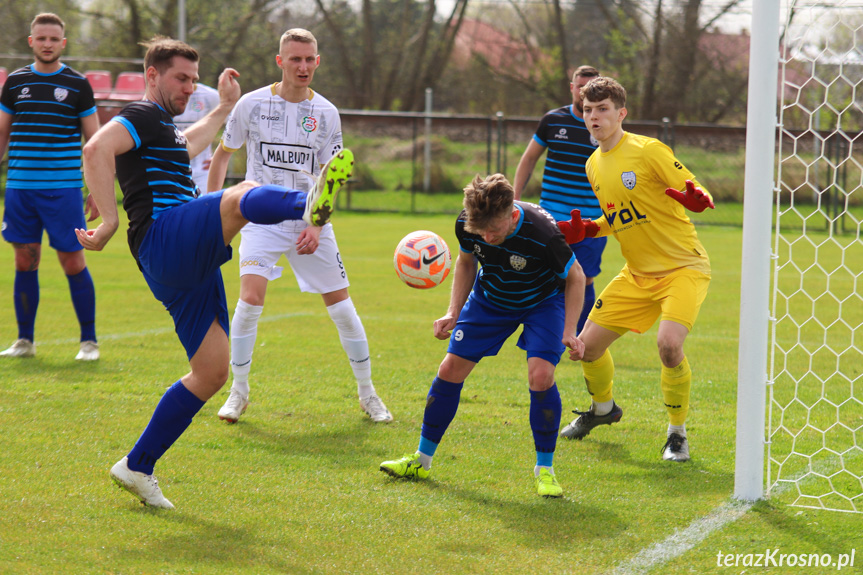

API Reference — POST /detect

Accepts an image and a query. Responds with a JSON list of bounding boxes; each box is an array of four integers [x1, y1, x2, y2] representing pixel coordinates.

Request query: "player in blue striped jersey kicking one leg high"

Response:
[[76, 37, 353, 509]]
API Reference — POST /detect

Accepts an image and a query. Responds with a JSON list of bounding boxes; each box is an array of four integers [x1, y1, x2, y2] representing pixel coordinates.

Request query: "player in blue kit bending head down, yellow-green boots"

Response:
[[381, 174, 584, 497]]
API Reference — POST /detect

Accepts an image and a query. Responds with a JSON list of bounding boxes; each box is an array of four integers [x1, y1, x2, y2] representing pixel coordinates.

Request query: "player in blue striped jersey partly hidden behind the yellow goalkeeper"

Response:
[[514, 66, 608, 333]]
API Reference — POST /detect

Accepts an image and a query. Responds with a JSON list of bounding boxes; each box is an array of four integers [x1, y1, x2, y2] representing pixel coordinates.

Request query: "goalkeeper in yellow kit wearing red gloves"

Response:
[[558, 77, 714, 461]]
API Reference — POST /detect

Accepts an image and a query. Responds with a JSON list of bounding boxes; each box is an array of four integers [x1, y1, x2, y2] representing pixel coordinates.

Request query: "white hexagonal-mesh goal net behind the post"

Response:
[[768, 0, 863, 513]]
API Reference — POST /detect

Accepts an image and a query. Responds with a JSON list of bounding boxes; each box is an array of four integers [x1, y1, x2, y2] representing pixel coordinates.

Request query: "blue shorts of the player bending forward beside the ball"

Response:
[[447, 283, 566, 365]]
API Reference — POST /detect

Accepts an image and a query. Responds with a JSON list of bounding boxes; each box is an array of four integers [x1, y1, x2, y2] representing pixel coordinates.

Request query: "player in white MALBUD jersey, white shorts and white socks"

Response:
[[208, 28, 393, 423]]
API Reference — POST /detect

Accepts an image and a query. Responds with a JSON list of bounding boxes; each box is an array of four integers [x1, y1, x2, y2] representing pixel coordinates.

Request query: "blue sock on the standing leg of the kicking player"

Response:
[[129, 381, 206, 475]]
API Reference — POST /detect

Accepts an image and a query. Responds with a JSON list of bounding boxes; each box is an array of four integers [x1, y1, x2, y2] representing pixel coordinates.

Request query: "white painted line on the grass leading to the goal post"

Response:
[[612, 500, 752, 575]]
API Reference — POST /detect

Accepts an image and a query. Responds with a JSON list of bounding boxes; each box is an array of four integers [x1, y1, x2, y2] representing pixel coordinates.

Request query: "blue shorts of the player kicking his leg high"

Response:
[[138, 192, 232, 360]]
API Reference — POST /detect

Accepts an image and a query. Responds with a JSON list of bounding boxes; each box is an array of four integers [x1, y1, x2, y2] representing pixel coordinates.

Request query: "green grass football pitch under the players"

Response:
[[0, 209, 863, 574]]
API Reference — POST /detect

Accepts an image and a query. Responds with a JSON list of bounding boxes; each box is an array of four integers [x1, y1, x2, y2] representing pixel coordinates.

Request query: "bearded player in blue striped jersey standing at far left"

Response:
[[0, 13, 99, 361]]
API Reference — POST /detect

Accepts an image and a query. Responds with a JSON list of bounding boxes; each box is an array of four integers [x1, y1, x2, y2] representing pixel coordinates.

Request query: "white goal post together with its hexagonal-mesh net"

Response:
[[734, 0, 863, 513]]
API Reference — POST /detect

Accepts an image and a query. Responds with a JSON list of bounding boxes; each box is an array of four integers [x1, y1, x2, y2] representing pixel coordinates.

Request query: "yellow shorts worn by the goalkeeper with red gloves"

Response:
[[588, 266, 710, 334]]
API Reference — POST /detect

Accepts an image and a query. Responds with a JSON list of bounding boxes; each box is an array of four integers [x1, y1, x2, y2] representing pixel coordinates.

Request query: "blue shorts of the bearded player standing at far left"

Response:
[[3, 188, 87, 252]]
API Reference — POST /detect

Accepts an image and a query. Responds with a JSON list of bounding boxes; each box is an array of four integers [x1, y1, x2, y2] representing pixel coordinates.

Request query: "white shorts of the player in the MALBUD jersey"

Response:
[[240, 220, 350, 293]]
